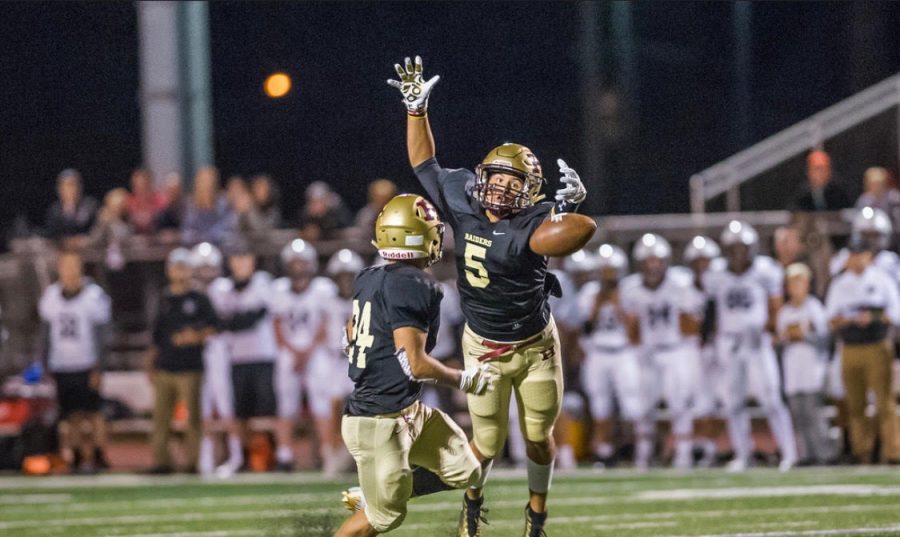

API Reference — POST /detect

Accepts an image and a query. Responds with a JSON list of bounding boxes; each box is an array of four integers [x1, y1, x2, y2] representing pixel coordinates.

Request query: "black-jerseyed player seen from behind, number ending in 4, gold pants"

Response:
[[336, 194, 493, 537]]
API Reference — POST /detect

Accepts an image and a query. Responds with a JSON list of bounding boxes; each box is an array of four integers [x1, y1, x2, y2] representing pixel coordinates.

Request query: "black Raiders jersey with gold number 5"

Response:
[[415, 159, 555, 341]]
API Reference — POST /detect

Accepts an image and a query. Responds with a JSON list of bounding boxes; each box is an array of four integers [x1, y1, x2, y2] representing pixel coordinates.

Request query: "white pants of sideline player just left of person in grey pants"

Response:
[[716, 334, 797, 464]]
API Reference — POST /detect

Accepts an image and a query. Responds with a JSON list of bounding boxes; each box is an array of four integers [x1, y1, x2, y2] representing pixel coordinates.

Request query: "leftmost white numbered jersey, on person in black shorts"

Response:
[[38, 283, 112, 372]]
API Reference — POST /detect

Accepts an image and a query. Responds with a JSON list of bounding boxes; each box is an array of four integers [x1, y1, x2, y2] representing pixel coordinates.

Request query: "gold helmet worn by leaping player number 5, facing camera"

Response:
[[473, 143, 544, 215]]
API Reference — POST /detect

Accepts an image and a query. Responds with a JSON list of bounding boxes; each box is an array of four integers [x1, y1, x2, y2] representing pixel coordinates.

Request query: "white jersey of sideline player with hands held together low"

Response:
[[269, 277, 337, 349]]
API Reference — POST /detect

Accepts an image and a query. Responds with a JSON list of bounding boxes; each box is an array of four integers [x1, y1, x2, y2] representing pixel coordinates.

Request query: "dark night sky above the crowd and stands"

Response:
[[0, 2, 900, 234]]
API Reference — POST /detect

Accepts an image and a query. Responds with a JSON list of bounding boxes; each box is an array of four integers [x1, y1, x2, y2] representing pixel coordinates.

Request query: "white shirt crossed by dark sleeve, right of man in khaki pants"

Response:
[[209, 271, 277, 363]]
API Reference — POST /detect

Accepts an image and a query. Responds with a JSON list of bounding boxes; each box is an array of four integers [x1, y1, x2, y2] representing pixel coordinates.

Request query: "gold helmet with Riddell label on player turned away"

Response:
[[372, 194, 444, 265]]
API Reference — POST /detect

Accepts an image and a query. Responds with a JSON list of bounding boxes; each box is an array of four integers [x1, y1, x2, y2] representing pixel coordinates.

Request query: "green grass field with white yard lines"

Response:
[[0, 467, 900, 537]]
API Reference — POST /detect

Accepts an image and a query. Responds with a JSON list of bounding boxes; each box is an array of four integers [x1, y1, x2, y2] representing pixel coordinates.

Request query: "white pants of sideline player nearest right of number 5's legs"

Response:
[[581, 348, 644, 422]]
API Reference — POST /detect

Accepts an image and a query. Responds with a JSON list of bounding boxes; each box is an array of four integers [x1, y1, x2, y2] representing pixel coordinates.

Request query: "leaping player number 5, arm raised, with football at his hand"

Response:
[[388, 56, 596, 537]]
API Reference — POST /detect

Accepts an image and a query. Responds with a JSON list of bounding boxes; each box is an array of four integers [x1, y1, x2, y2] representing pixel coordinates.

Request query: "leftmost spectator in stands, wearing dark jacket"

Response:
[[44, 168, 97, 239]]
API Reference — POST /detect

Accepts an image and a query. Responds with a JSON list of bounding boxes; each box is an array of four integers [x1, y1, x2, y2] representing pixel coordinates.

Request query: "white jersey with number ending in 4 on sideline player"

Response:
[[621, 270, 697, 347]]
